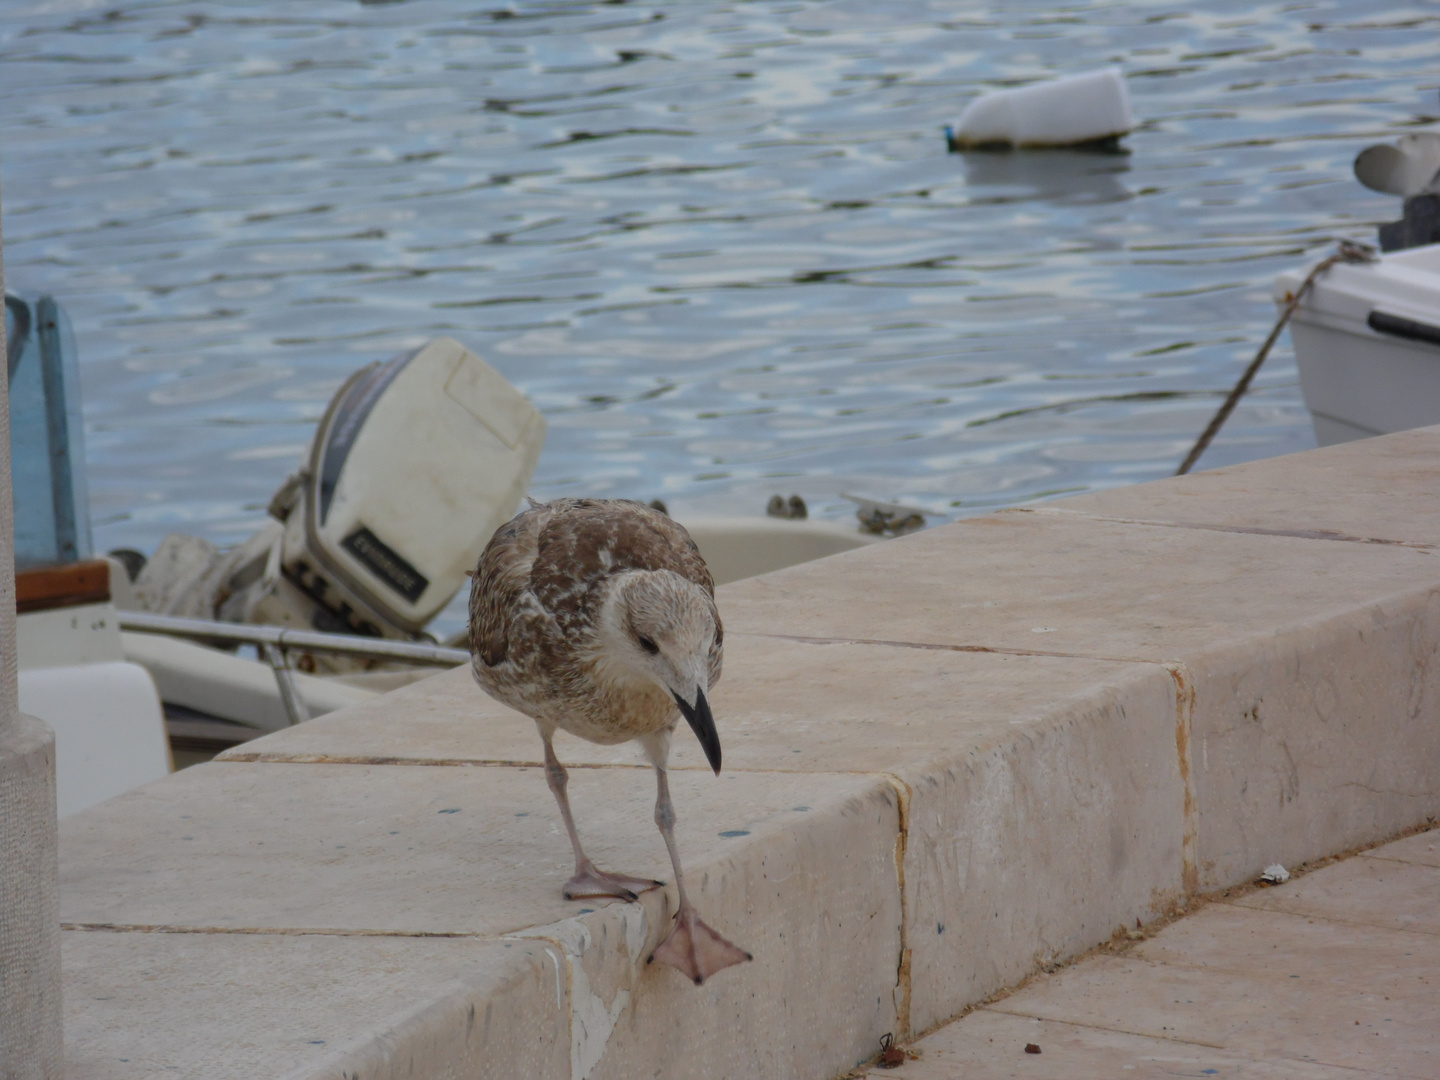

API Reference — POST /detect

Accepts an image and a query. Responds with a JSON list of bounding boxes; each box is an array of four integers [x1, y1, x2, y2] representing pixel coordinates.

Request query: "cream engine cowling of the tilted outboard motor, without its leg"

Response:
[[271, 337, 544, 636]]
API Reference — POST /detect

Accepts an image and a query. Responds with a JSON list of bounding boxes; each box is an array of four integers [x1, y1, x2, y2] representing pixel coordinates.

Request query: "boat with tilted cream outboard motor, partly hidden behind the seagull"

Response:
[[114, 338, 874, 753]]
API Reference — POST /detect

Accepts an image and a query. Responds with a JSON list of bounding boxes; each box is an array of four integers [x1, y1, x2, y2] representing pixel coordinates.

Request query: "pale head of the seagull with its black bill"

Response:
[[598, 570, 721, 773]]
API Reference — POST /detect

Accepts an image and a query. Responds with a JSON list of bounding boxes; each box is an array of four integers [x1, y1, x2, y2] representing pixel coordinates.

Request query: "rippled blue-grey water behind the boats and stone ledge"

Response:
[[0, 0, 1440, 630]]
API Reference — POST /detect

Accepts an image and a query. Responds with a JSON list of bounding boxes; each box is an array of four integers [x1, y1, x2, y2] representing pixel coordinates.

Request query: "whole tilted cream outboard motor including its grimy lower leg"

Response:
[[135, 337, 546, 650]]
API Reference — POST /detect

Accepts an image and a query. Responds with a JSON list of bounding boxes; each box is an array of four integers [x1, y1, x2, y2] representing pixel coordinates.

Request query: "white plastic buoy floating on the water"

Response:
[[945, 68, 1135, 150]]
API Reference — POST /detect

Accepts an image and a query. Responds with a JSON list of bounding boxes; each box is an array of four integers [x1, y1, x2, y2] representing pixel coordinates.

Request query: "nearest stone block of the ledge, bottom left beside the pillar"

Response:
[[63, 930, 570, 1080]]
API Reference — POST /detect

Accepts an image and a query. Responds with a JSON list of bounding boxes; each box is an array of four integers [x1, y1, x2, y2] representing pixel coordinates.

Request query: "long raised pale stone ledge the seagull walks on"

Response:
[[62, 429, 1440, 1080]]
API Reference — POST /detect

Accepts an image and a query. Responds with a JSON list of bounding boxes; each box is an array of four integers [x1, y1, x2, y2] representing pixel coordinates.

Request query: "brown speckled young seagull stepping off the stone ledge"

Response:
[[469, 498, 752, 985]]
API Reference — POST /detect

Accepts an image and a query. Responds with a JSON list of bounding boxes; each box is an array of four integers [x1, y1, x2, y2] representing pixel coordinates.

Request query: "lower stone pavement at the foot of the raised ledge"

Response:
[[865, 832, 1440, 1080]]
